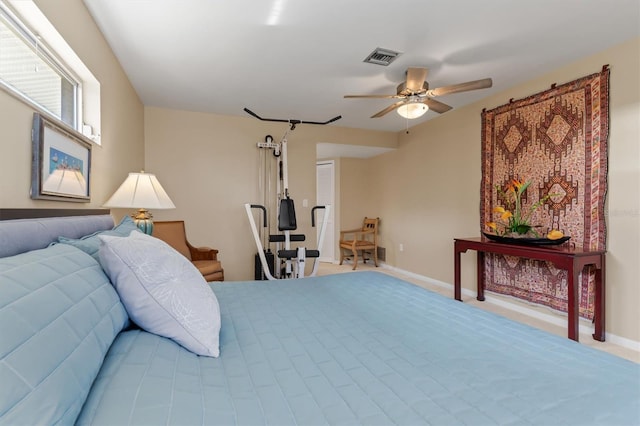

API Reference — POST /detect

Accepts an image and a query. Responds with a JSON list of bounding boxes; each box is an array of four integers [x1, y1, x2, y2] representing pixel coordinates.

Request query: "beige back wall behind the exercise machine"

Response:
[[144, 107, 397, 280]]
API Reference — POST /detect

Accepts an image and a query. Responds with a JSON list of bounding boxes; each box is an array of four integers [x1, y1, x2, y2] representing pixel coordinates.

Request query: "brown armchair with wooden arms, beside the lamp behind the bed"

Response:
[[152, 220, 224, 281]]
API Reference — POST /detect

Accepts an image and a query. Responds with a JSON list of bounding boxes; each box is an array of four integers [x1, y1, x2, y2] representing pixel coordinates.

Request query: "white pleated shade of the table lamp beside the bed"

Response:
[[104, 172, 176, 209]]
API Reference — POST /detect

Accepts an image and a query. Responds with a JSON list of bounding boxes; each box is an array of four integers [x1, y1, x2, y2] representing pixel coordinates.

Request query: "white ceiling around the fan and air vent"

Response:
[[84, 0, 640, 131]]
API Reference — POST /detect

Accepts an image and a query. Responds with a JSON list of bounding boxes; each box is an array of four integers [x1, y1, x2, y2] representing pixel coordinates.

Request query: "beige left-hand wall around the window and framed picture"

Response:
[[0, 0, 144, 208]]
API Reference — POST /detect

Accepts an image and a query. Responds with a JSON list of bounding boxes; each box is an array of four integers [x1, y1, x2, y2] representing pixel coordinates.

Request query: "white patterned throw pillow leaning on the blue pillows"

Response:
[[99, 232, 220, 357]]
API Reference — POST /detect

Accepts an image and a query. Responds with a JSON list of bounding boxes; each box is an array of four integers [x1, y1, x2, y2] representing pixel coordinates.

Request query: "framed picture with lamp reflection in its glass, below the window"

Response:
[[31, 113, 91, 202]]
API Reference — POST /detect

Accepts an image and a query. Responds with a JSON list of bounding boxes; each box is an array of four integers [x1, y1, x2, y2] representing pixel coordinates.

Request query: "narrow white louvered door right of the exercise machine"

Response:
[[316, 160, 336, 262]]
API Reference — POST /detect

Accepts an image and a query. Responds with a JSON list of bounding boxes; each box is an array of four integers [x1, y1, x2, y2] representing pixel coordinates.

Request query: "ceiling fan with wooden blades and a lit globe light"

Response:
[[345, 67, 493, 118]]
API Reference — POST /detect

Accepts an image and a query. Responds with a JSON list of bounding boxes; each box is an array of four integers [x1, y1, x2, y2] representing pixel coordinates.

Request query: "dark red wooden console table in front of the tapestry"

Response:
[[454, 237, 605, 342]]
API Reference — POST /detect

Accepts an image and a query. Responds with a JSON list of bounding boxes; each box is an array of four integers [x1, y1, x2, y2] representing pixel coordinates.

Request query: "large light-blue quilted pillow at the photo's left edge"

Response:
[[0, 244, 128, 425]]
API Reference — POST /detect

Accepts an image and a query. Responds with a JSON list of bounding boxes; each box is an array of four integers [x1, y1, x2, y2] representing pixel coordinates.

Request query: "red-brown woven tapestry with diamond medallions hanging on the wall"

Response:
[[480, 66, 609, 319]]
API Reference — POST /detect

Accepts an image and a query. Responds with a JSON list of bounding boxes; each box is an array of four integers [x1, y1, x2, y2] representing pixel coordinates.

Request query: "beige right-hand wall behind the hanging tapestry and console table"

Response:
[[358, 39, 640, 342]]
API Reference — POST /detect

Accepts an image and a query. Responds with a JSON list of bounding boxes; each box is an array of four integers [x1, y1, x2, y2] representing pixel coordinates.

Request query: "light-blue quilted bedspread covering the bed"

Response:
[[79, 272, 640, 425]]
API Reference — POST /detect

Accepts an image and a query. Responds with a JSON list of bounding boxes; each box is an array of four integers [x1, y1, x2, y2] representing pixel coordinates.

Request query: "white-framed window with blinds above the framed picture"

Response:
[[0, 0, 100, 143]]
